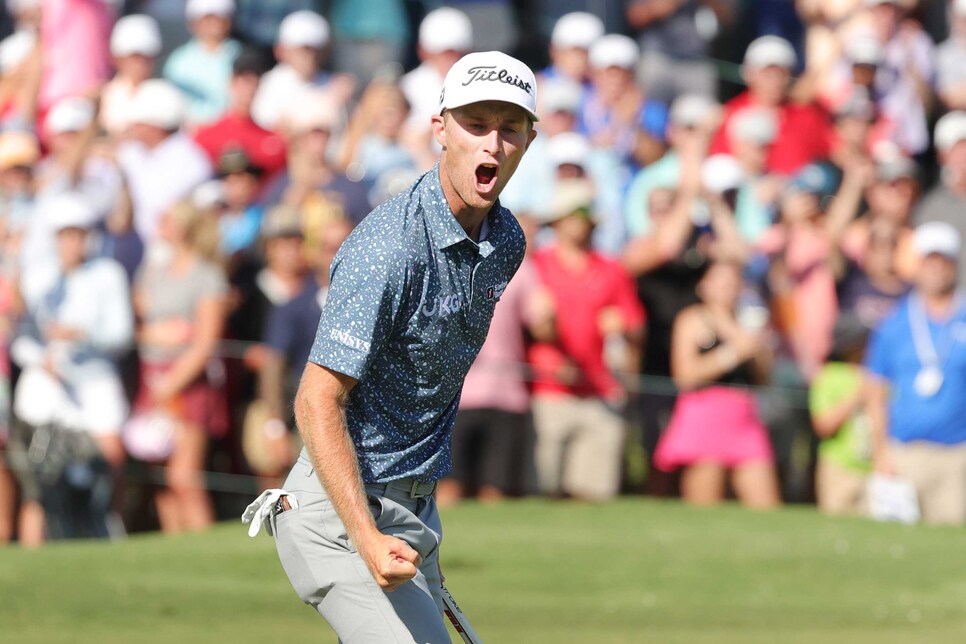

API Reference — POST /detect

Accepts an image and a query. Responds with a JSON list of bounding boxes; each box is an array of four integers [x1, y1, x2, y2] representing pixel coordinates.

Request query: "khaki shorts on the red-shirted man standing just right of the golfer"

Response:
[[533, 396, 625, 500]]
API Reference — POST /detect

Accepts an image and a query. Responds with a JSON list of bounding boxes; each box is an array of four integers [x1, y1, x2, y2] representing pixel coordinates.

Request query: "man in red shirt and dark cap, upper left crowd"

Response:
[[195, 50, 286, 177]]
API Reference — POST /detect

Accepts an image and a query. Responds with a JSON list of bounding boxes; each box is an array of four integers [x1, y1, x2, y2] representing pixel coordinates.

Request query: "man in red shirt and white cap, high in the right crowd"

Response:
[[710, 36, 834, 175]]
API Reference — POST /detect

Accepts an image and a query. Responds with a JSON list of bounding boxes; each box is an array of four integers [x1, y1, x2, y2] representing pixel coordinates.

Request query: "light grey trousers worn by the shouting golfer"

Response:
[[272, 455, 450, 644]]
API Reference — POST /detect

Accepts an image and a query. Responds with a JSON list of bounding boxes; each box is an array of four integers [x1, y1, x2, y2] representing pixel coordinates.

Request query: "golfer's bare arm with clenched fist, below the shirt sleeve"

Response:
[[295, 363, 419, 590]]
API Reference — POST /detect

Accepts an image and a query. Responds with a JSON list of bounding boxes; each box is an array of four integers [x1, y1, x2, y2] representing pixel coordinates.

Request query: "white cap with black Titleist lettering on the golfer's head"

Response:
[[439, 51, 539, 121]]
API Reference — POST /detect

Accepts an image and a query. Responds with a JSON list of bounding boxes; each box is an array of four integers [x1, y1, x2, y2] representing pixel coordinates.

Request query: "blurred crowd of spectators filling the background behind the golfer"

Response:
[[0, 0, 966, 545]]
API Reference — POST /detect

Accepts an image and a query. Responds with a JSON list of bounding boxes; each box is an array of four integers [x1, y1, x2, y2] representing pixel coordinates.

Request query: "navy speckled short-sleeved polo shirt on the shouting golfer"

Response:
[[309, 164, 526, 483]]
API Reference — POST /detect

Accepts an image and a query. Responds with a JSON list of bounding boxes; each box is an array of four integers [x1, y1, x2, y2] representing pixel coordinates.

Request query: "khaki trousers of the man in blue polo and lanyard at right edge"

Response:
[[892, 441, 966, 525]]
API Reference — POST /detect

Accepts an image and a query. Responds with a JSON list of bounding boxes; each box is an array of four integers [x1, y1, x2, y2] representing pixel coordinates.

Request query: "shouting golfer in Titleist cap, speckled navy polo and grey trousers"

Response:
[[271, 52, 537, 644]]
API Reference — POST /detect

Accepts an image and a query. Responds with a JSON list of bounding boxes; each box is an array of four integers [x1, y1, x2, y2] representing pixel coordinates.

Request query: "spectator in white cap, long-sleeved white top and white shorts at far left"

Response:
[[11, 194, 134, 546]]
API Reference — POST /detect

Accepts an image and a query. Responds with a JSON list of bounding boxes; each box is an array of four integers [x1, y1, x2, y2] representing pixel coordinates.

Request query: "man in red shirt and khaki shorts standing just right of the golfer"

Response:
[[529, 179, 644, 500]]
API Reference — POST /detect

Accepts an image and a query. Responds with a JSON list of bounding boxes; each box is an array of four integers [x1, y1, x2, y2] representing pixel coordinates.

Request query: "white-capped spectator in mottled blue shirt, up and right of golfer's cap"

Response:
[[579, 34, 667, 166]]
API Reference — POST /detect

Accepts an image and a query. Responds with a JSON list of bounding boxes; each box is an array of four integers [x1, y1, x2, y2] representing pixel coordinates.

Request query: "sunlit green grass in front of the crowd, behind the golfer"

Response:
[[0, 499, 966, 644]]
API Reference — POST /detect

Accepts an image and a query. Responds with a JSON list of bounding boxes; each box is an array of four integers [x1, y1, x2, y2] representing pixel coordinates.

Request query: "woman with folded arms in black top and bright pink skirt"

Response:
[[654, 262, 780, 509]]
